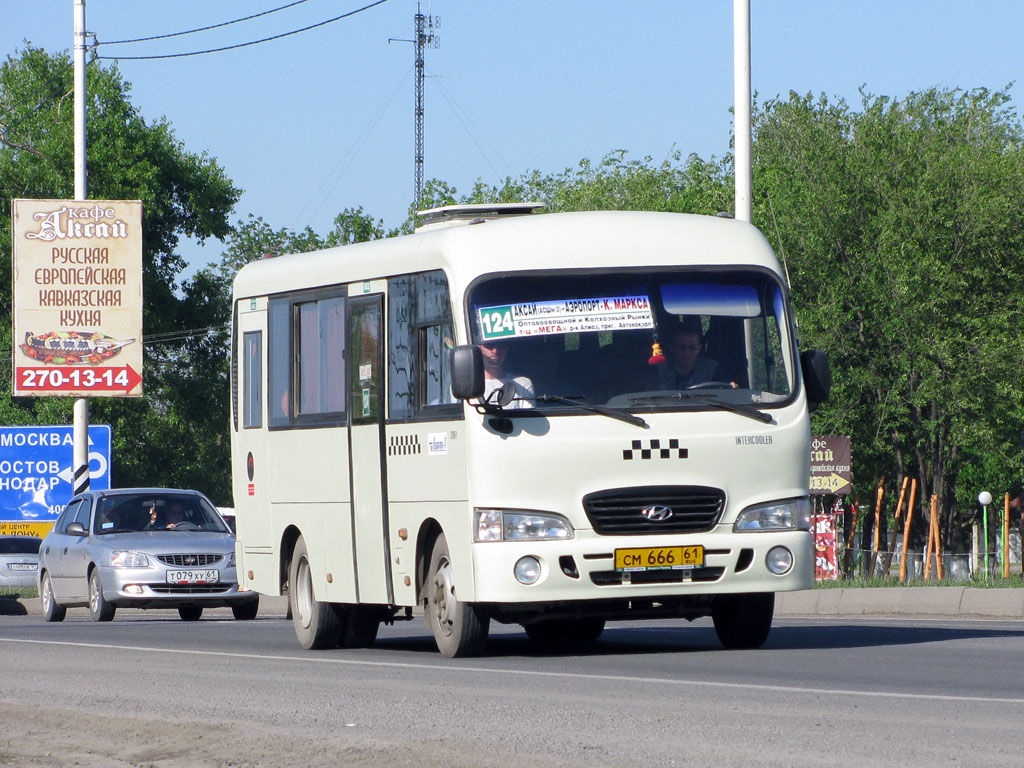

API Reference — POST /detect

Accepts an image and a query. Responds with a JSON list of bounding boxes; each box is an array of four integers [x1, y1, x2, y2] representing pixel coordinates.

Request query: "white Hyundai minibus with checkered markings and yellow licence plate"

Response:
[[231, 204, 830, 656]]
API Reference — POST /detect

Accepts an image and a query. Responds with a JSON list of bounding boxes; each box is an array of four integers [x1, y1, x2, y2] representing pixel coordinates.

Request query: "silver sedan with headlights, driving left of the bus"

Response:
[[38, 488, 259, 622]]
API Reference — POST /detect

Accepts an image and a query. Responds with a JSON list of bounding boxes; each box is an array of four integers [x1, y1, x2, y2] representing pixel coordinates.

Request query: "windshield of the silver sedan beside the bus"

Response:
[[93, 493, 229, 535]]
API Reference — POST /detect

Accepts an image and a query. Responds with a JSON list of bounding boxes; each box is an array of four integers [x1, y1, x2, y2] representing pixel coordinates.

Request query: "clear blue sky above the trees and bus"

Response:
[[0, 0, 1024, 276]]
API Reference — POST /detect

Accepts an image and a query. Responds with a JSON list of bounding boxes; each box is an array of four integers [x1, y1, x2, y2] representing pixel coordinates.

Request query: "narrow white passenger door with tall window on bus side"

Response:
[[347, 294, 394, 604]]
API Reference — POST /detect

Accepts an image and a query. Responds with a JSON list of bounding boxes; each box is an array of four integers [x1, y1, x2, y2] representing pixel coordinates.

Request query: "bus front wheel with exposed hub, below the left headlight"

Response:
[[424, 534, 490, 658]]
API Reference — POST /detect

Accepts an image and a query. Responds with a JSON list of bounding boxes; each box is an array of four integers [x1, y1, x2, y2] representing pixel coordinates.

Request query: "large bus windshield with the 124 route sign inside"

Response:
[[469, 268, 795, 417]]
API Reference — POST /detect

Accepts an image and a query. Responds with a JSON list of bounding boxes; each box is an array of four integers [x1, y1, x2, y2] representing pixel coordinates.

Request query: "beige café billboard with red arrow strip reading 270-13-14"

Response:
[[11, 200, 142, 397]]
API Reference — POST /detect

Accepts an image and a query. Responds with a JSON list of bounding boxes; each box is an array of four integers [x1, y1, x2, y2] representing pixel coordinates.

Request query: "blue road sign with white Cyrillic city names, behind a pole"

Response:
[[0, 424, 111, 537]]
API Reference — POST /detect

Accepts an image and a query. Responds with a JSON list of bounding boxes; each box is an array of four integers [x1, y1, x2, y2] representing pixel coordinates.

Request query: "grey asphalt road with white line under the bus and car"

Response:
[[0, 610, 1024, 768]]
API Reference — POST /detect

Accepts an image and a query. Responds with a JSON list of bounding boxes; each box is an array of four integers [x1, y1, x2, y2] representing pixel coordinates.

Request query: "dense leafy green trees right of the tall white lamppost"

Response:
[[754, 89, 1024, 546]]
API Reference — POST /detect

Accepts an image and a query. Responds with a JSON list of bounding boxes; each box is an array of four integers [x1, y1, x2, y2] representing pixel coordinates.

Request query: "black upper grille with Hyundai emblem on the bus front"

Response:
[[583, 485, 725, 536]]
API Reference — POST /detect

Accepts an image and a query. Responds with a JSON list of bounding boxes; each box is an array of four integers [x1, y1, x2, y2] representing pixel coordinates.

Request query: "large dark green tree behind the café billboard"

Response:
[[0, 46, 240, 501]]
